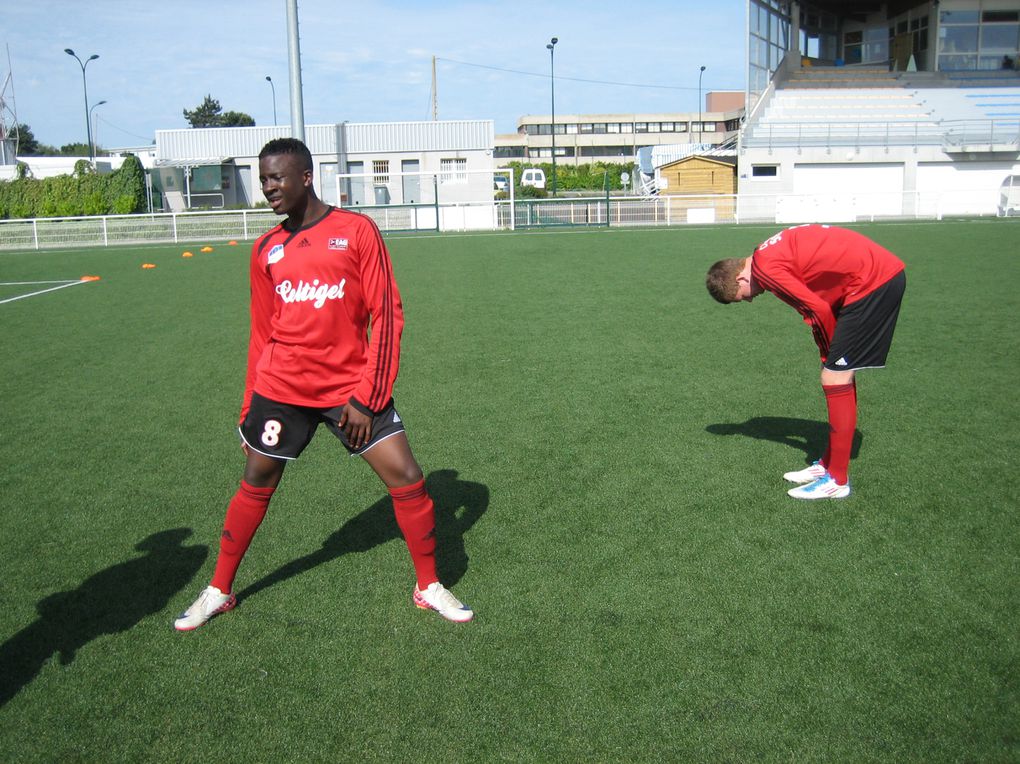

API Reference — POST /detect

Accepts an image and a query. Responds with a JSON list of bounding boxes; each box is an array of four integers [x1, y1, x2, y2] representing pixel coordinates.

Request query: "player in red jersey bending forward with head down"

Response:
[[706, 225, 907, 499]]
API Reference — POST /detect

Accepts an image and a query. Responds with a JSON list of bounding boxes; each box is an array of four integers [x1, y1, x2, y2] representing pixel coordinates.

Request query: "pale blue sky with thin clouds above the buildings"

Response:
[[0, 0, 746, 147]]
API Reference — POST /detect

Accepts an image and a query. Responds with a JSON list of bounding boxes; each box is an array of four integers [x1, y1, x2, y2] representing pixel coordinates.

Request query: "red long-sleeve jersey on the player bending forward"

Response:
[[751, 225, 904, 358]]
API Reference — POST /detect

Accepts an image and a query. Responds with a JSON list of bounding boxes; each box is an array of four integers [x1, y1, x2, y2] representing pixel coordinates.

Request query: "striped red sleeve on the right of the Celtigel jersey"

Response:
[[351, 217, 404, 413]]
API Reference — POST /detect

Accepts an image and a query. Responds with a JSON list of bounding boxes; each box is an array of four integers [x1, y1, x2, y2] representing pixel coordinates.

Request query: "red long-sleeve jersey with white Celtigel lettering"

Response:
[[241, 207, 404, 421]]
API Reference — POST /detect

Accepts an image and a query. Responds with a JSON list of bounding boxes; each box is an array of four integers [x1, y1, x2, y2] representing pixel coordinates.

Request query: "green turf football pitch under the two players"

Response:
[[0, 220, 1020, 762]]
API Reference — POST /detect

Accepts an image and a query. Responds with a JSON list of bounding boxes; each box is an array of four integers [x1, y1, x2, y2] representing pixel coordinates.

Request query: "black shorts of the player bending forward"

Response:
[[822, 270, 907, 371]]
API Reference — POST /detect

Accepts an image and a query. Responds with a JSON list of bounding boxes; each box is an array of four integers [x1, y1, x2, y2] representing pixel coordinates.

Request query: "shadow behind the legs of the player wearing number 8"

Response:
[[237, 469, 489, 601]]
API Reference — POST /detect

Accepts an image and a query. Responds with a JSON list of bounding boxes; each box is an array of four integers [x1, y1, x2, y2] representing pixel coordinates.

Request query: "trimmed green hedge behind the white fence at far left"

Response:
[[0, 155, 147, 218]]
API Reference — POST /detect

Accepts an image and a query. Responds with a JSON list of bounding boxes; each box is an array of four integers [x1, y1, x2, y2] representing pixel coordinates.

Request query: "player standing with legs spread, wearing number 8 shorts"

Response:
[[173, 138, 473, 631]]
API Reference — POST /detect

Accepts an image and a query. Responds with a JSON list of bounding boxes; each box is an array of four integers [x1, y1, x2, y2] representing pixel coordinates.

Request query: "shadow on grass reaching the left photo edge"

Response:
[[0, 528, 209, 707]]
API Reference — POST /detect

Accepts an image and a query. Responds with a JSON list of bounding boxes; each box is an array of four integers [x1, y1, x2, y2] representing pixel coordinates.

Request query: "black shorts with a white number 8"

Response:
[[238, 393, 404, 459]]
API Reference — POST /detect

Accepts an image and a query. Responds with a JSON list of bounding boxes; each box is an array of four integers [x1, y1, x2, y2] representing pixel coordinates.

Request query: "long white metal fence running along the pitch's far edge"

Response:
[[0, 190, 1020, 251]]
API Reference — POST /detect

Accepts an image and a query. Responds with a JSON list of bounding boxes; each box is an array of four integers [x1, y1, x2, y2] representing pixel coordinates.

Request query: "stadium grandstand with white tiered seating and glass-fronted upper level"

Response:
[[737, 0, 1020, 222]]
